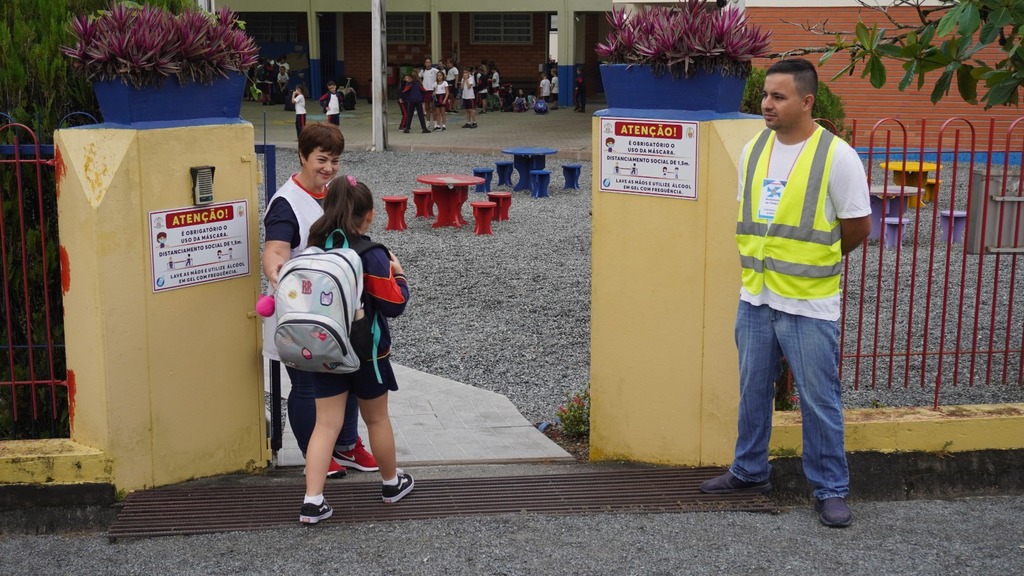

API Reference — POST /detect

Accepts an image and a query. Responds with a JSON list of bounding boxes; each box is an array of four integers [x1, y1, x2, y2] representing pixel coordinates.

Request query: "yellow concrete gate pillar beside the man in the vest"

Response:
[[590, 117, 764, 465]]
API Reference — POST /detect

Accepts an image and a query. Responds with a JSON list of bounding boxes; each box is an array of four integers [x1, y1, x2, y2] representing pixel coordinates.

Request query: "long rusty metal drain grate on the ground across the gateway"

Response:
[[108, 467, 776, 541]]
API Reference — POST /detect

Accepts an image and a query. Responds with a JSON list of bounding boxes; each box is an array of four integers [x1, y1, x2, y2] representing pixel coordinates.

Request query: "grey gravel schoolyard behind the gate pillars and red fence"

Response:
[[266, 150, 1024, 422]]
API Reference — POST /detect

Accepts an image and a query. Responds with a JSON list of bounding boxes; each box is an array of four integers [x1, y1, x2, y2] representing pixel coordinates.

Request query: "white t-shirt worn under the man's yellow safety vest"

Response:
[[737, 127, 871, 321]]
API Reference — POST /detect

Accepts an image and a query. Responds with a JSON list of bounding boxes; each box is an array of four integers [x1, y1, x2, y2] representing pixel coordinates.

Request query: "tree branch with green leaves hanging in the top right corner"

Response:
[[772, 0, 1024, 110]]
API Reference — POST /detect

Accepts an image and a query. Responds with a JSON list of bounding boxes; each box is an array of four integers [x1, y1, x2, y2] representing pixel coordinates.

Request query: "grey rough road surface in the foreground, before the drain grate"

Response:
[[0, 496, 1024, 576]]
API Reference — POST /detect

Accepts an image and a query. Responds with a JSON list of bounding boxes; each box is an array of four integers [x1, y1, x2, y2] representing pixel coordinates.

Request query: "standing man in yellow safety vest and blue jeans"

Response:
[[700, 59, 871, 528]]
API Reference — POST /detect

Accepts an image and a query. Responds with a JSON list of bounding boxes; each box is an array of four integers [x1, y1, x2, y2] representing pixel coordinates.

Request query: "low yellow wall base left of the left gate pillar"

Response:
[[0, 439, 113, 484]]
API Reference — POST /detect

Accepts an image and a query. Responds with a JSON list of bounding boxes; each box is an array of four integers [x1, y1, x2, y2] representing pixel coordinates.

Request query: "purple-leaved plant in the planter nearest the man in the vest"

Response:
[[595, 0, 771, 78]]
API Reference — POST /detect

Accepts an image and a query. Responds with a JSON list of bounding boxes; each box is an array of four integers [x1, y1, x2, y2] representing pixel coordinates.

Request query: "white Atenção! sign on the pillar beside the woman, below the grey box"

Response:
[[150, 200, 249, 292]]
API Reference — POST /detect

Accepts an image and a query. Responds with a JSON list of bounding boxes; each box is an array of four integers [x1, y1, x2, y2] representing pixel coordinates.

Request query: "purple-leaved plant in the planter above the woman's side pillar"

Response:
[[61, 2, 259, 87]]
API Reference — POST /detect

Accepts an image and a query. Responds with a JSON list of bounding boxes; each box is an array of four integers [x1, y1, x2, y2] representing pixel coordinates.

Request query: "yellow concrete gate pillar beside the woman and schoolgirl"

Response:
[[55, 123, 269, 490]]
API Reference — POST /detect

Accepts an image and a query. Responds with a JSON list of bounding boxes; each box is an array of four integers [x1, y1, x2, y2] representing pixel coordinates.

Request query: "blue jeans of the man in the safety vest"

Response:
[[729, 300, 850, 500]]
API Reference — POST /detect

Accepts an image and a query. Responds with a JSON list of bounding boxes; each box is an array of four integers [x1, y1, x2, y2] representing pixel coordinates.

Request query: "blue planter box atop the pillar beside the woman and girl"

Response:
[[92, 74, 246, 126]]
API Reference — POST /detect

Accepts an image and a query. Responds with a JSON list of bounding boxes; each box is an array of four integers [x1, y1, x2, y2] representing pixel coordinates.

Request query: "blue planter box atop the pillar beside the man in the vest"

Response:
[[600, 64, 746, 113]]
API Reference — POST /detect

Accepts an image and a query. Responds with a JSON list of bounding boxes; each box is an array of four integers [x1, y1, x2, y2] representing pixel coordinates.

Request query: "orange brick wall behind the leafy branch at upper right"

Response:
[[748, 7, 1021, 147]]
